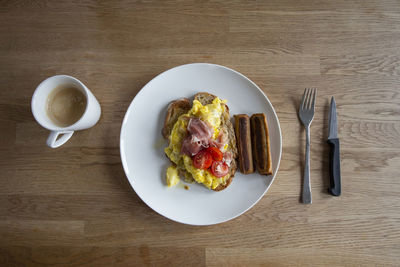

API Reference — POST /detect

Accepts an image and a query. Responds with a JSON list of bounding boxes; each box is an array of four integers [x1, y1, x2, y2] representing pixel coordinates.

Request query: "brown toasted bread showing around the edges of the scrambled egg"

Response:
[[162, 92, 238, 191]]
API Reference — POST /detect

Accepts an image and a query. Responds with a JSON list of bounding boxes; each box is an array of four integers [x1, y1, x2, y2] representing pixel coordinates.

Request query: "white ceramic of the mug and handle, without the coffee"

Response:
[[31, 75, 101, 148]]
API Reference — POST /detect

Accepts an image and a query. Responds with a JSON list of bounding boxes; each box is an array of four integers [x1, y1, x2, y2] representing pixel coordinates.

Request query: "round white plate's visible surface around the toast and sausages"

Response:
[[120, 63, 282, 225]]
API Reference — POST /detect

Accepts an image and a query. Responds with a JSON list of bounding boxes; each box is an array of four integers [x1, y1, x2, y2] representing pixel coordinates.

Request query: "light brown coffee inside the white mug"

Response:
[[46, 86, 87, 127]]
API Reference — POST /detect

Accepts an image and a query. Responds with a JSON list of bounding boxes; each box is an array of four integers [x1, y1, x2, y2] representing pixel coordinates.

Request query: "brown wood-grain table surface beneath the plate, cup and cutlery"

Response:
[[0, 0, 400, 266]]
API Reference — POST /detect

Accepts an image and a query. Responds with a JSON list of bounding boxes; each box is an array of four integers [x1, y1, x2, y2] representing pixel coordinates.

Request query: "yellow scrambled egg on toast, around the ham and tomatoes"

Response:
[[165, 97, 229, 189]]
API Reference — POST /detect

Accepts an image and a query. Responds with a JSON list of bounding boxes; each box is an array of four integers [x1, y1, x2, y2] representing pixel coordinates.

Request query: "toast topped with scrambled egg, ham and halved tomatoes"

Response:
[[162, 93, 237, 191]]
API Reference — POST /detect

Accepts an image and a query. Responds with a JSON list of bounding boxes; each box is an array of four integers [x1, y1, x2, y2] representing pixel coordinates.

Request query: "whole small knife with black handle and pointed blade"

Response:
[[328, 97, 341, 196]]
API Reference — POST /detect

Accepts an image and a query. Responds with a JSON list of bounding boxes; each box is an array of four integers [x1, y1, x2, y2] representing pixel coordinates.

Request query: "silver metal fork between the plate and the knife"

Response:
[[299, 88, 317, 204]]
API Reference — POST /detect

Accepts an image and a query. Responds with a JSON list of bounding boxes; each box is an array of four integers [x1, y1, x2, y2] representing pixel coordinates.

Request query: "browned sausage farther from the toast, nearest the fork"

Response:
[[250, 113, 272, 175]]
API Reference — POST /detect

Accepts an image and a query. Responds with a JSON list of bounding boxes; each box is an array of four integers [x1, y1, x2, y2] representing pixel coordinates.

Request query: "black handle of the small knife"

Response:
[[328, 138, 342, 196]]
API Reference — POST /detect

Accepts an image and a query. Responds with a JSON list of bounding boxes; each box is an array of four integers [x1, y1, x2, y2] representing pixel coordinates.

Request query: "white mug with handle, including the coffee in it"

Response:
[[31, 75, 101, 148]]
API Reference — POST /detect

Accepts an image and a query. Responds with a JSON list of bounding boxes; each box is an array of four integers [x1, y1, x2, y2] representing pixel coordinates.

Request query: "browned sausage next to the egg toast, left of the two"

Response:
[[233, 114, 254, 174]]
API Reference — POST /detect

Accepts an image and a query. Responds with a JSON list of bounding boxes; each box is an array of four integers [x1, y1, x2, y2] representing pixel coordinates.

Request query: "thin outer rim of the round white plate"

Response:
[[119, 62, 282, 226]]
